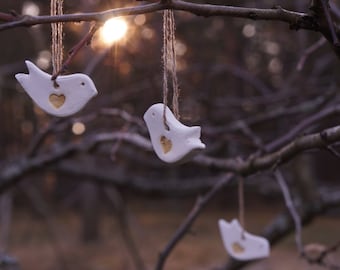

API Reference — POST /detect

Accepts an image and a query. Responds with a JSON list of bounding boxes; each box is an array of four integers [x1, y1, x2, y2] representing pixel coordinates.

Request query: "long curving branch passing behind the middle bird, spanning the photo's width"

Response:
[[0, 123, 340, 193]]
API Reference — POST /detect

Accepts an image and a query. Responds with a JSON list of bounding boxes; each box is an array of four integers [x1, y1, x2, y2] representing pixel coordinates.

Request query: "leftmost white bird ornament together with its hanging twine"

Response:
[[15, 0, 97, 117]]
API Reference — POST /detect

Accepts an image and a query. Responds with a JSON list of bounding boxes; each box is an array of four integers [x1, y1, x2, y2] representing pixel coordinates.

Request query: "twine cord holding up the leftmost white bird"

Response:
[[51, 0, 64, 84]]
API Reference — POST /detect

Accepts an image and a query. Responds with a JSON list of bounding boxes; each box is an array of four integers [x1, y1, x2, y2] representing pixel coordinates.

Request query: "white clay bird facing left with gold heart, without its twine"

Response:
[[144, 103, 205, 163]]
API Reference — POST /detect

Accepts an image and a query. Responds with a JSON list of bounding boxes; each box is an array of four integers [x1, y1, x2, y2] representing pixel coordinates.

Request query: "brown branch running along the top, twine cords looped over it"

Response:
[[0, 0, 318, 31]]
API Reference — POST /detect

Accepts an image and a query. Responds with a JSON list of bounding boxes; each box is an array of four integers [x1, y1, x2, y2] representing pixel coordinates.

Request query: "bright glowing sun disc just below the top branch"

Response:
[[100, 18, 128, 45]]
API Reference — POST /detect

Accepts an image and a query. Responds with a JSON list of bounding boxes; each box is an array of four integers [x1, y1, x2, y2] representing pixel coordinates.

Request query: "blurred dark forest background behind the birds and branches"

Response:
[[0, 0, 340, 270]]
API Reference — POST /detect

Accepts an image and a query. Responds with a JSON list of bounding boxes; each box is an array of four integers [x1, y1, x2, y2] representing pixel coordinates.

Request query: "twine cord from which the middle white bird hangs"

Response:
[[162, 10, 180, 129]]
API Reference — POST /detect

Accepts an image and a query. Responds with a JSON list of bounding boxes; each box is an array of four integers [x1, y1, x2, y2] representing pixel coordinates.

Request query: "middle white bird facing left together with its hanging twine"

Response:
[[144, 10, 205, 163]]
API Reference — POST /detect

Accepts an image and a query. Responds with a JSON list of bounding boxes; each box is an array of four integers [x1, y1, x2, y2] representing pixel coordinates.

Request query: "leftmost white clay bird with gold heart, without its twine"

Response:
[[15, 61, 98, 117]]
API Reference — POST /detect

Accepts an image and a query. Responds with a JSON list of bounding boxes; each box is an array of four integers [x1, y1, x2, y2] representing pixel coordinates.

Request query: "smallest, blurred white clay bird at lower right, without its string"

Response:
[[218, 219, 270, 261]]
